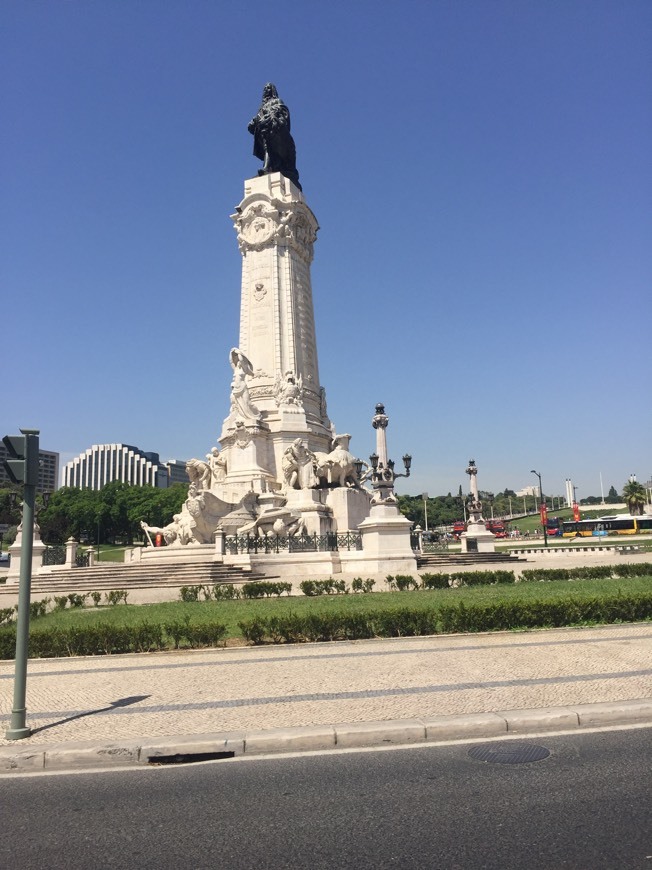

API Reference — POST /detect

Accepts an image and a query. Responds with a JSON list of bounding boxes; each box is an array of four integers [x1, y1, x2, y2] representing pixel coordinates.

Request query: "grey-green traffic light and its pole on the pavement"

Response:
[[2, 429, 39, 740]]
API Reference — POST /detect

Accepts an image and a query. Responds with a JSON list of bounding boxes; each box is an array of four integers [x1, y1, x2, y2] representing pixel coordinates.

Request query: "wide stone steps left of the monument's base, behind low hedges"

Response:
[[25, 562, 269, 595]]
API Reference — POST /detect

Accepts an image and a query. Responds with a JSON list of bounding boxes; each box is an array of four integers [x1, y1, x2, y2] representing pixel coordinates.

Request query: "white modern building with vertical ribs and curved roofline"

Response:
[[63, 444, 168, 489]]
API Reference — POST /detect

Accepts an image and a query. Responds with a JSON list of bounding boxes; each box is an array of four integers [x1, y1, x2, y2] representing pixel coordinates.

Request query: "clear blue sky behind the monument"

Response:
[[0, 0, 652, 497]]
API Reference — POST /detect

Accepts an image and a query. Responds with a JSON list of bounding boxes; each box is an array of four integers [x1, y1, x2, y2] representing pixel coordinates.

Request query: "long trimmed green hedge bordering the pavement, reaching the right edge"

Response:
[[238, 592, 652, 644]]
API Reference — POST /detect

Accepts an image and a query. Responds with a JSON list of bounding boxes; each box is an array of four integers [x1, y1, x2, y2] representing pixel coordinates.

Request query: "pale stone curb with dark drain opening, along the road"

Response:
[[0, 699, 652, 773]]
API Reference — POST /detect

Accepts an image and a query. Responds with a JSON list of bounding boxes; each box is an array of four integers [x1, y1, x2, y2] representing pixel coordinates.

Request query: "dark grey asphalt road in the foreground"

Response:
[[0, 729, 652, 870]]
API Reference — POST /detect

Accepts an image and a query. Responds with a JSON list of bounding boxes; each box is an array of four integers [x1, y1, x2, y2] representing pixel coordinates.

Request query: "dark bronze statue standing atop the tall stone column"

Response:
[[247, 82, 301, 190]]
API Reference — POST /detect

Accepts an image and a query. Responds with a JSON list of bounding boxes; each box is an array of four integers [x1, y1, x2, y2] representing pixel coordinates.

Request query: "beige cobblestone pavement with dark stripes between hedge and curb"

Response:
[[0, 624, 652, 748]]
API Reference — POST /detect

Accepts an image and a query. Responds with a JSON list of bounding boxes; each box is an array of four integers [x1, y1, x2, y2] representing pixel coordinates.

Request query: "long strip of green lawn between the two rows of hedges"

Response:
[[32, 577, 652, 638]]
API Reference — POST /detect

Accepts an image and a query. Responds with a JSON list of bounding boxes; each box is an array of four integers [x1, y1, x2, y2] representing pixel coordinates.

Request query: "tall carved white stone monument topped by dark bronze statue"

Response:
[[142, 84, 370, 546]]
